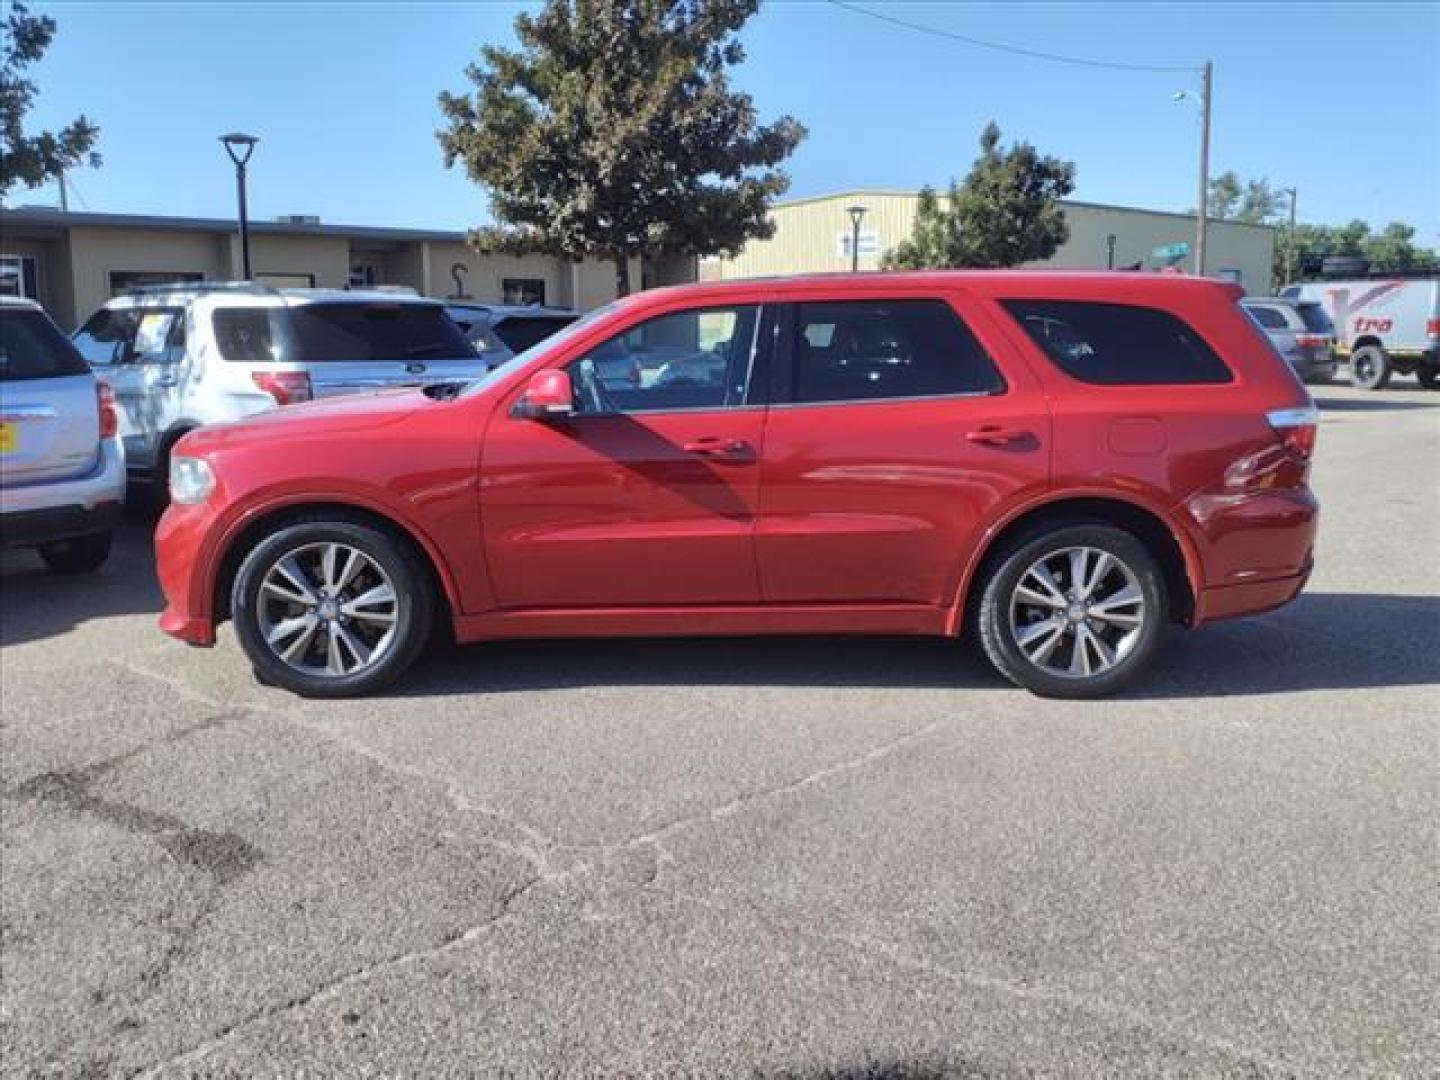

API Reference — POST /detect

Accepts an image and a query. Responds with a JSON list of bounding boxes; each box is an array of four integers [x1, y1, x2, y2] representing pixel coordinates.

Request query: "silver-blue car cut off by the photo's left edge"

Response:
[[0, 297, 125, 573]]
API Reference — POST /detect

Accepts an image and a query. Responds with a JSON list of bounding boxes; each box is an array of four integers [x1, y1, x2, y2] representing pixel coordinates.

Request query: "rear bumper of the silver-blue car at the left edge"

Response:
[[0, 439, 125, 547]]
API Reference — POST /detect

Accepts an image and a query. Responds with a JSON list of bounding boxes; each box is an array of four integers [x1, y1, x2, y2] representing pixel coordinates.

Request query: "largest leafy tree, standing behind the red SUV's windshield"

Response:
[[438, 0, 805, 295]]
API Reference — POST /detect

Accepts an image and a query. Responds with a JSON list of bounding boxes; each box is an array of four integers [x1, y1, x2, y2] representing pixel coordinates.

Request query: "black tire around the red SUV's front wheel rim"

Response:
[[230, 517, 435, 697]]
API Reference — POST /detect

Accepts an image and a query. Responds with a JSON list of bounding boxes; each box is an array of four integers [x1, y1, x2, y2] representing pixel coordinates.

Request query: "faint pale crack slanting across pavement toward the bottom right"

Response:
[[658, 888, 1295, 1077]]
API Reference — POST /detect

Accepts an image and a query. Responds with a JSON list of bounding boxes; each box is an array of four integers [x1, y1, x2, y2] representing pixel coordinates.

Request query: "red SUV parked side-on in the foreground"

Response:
[[157, 272, 1318, 697]]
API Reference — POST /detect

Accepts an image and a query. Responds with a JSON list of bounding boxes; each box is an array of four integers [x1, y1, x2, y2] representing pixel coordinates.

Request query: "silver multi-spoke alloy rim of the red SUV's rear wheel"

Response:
[[1009, 547, 1148, 678]]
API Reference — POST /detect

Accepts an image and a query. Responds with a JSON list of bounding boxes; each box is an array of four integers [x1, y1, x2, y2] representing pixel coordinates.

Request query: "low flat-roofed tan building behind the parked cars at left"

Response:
[[0, 207, 696, 330]]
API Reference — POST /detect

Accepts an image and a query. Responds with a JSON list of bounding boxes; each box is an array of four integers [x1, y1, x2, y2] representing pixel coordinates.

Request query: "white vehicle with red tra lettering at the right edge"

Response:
[[1282, 278, 1440, 390]]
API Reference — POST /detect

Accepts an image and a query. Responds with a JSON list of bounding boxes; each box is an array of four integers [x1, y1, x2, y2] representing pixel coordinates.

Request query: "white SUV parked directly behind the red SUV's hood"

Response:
[[75, 282, 484, 492]]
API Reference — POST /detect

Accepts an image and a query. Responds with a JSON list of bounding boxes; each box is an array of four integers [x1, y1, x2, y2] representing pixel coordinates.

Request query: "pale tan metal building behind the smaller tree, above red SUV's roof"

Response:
[[700, 190, 1274, 295]]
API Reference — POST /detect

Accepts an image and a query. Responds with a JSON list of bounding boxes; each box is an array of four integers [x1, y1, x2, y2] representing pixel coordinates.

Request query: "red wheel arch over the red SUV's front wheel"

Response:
[[209, 495, 461, 624]]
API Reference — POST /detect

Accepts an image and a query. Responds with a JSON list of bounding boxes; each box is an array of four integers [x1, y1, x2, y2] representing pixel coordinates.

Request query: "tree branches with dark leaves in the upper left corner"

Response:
[[0, 3, 99, 199]]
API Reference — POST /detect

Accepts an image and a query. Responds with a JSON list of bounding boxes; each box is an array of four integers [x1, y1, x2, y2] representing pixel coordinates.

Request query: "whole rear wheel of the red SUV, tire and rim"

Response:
[[976, 524, 1166, 698]]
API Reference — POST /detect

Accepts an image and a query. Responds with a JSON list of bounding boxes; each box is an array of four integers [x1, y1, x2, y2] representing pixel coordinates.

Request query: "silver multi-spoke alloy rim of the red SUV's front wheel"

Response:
[[256, 543, 399, 678]]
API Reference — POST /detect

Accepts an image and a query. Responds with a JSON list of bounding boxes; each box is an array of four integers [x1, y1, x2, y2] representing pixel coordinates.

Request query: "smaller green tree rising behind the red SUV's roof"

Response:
[[881, 121, 1076, 269]]
